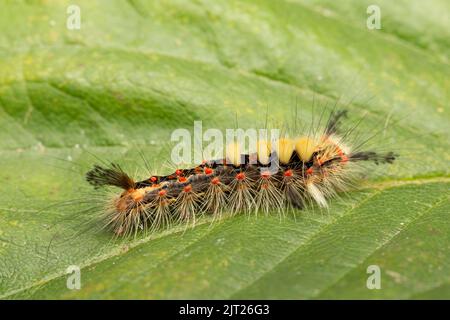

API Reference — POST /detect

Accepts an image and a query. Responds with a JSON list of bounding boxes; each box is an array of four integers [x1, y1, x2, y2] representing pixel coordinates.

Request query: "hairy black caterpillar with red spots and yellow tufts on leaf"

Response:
[[86, 110, 397, 236]]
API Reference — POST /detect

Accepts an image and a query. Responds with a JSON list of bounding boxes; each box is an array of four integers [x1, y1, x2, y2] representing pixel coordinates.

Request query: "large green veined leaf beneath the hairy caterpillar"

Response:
[[0, 0, 450, 299]]
